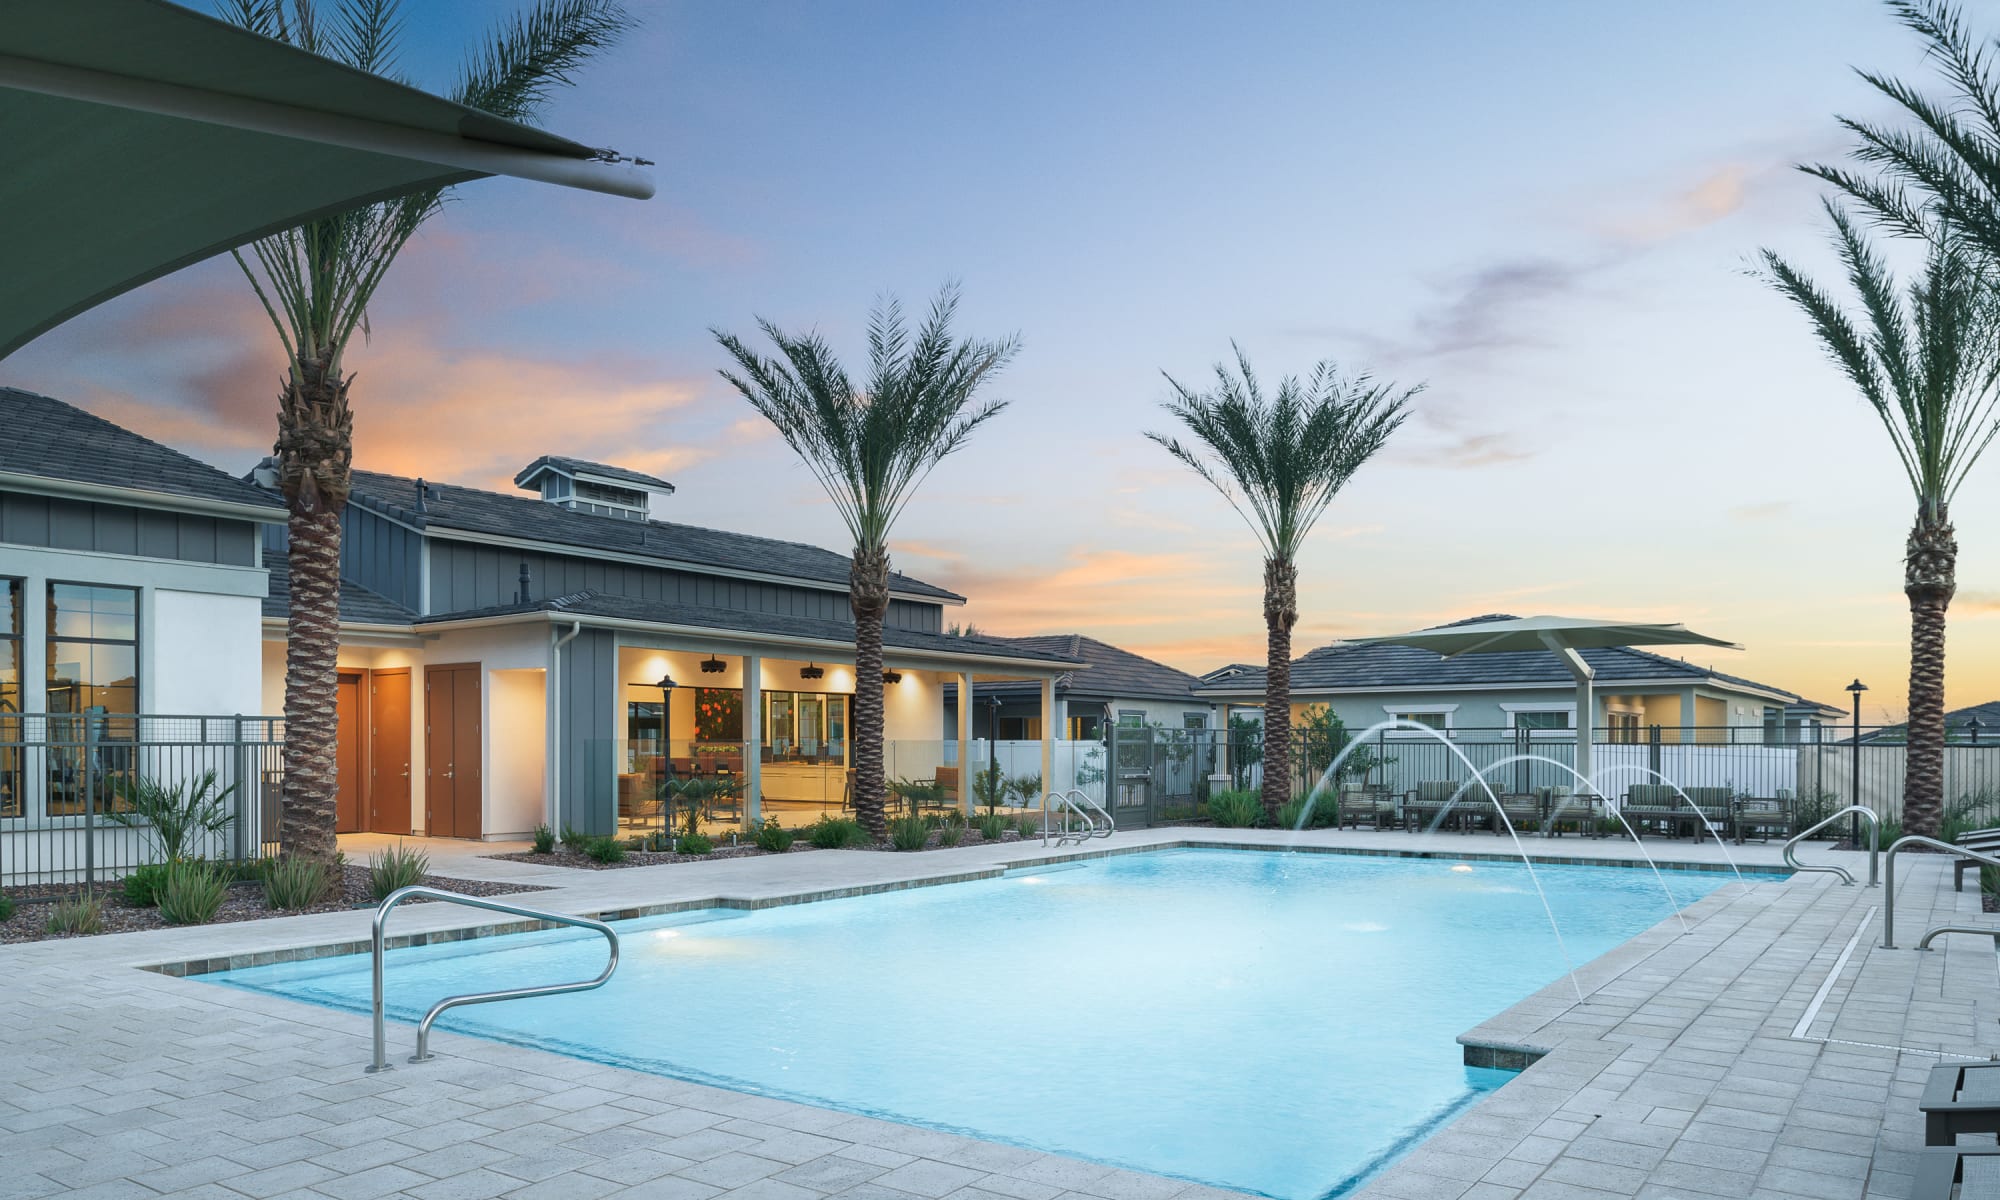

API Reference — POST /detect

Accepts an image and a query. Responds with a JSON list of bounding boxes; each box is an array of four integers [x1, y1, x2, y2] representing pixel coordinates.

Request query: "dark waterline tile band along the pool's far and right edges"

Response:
[[136, 838, 1794, 980]]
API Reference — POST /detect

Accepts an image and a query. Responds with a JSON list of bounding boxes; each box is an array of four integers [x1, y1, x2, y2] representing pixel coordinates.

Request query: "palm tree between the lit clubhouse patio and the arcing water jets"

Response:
[[1146, 348, 1424, 820]]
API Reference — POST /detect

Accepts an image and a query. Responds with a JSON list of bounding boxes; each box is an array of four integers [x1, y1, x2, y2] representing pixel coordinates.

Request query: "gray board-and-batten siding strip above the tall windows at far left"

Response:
[[0, 492, 258, 566]]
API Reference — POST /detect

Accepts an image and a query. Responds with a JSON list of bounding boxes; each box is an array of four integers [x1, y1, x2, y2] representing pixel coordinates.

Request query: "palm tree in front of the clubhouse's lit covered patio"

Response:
[[710, 284, 1020, 838]]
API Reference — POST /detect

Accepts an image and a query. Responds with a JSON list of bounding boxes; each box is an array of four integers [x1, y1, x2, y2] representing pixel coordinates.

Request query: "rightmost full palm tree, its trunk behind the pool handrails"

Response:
[[1762, 202, 2000, 838]]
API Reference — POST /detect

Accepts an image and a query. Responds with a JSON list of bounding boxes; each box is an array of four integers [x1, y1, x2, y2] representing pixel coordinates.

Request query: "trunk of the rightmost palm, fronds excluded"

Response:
[[1902, 508, 1958, 838]]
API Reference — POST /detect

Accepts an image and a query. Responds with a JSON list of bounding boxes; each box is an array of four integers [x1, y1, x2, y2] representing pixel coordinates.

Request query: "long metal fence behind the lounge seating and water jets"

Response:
[[1106, 726, 2000, 826]]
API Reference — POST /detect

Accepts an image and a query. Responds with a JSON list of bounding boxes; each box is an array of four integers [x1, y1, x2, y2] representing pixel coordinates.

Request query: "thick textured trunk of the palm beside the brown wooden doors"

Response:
[[278, 362, 354, 866]]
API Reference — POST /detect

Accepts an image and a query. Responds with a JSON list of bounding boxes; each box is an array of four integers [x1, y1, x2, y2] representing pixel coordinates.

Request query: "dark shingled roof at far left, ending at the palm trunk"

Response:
[[0, 388, 284, 520]]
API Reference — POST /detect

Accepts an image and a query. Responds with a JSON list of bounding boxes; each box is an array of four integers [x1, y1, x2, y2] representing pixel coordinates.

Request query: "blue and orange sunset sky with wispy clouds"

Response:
[[0, 0, 2000, 722]]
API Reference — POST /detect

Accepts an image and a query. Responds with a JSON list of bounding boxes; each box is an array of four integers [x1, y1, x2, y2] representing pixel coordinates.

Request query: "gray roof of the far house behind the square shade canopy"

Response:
[[1196, 614, 1810, 704]]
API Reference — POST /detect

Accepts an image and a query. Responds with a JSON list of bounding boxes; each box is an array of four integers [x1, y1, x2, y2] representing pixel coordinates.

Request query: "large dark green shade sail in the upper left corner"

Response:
[[0, 0, 652, 358]]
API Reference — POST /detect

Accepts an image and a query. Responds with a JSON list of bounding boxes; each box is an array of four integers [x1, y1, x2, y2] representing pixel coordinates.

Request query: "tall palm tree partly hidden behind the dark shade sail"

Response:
[[230, 0, 630, 864]]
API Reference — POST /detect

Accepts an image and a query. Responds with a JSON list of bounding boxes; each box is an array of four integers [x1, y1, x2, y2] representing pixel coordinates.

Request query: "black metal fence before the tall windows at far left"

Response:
[[0, 714, 284, 890]]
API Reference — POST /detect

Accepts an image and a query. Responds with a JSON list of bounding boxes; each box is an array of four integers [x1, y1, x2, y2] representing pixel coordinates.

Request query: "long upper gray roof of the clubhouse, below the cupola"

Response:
[[354, 470, 964, 602]]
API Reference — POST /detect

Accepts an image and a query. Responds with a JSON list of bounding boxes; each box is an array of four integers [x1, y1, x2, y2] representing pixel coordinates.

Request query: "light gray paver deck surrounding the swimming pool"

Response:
[[0, 830, 2000, 1200]]
